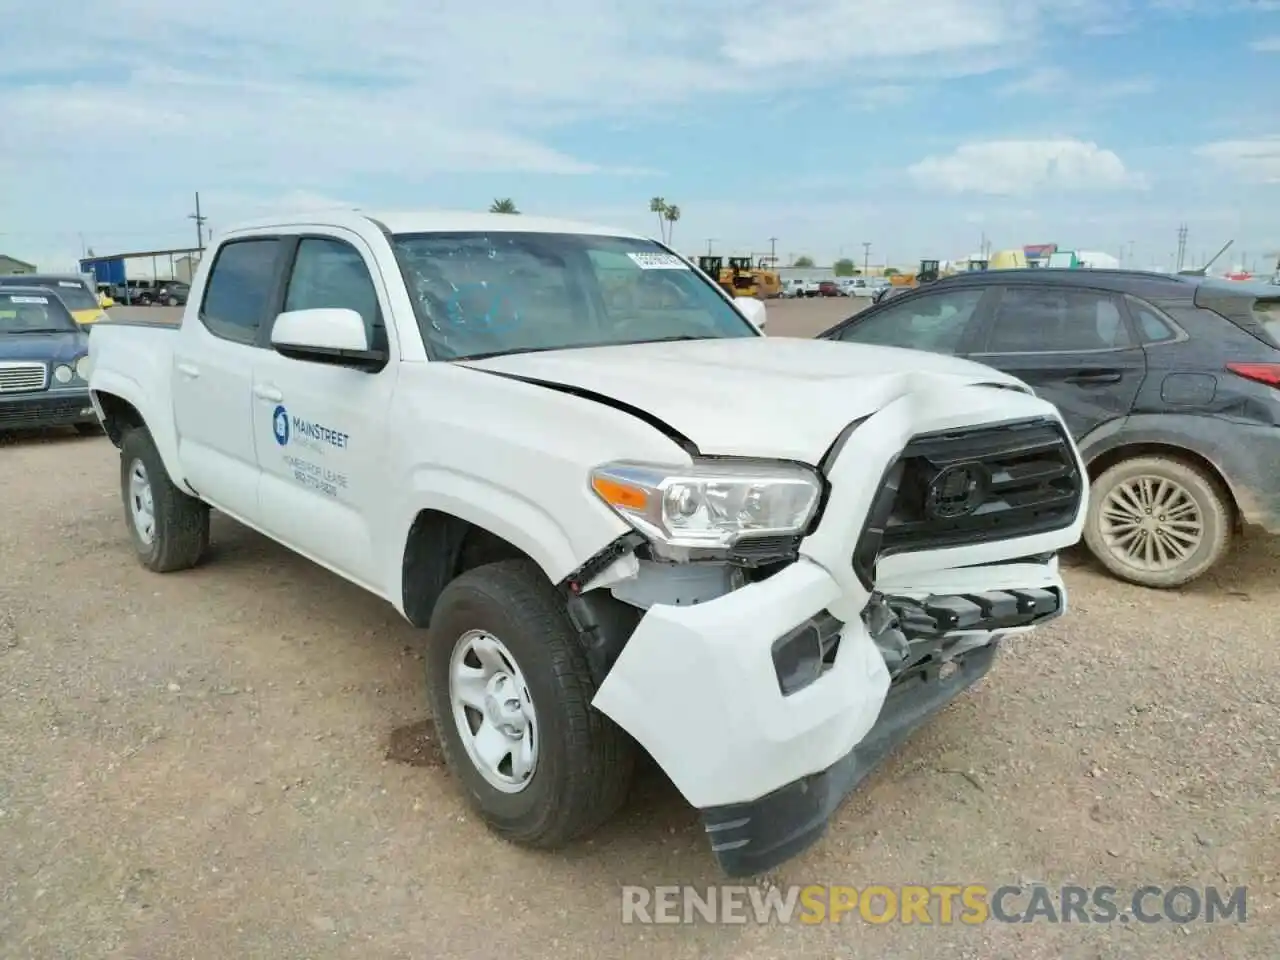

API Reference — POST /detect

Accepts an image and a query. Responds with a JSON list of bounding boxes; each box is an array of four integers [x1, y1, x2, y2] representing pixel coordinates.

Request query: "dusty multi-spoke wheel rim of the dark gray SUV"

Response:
[[1100, 476, 1204, 573]]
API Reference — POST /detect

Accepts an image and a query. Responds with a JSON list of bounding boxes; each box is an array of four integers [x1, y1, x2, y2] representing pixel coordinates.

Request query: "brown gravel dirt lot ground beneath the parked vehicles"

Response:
[[0, 296, 1280, 960]]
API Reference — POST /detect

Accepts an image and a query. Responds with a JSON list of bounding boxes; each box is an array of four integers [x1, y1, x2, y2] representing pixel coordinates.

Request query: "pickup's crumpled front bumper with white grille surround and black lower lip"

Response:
[[593, 387, 1087, 873]]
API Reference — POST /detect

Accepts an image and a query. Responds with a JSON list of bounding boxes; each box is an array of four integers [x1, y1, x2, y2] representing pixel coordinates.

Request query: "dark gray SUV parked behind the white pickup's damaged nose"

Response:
[[819, 269, 1280, 588]]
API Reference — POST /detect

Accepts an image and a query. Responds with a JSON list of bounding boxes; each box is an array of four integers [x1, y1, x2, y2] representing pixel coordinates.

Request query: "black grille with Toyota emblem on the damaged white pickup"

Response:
[[854, 419, 1084, 588]]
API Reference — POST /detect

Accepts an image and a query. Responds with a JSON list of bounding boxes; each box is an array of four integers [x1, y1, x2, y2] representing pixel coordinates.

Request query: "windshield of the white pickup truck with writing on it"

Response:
[[393, 233, 760, 360]]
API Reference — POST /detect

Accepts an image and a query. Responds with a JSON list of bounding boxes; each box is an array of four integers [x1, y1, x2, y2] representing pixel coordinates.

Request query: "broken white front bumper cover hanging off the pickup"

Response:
[[593, 558, 1066, 810]]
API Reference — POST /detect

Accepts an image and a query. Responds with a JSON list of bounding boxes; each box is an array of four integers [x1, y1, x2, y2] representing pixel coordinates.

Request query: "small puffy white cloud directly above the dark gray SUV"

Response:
[[908, 140, 1144, 196]]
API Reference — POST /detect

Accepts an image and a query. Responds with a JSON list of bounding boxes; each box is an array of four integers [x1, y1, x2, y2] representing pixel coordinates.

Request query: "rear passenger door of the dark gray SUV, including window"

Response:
[[970, 283, 1147, 440]]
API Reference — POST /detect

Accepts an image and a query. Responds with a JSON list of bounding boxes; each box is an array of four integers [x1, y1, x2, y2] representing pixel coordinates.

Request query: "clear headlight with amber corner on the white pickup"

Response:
[[591, 461, 822, 549]]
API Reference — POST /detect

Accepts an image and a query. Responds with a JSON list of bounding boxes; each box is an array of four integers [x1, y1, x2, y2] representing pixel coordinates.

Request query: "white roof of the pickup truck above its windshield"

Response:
[[217, 207, 641, 239]]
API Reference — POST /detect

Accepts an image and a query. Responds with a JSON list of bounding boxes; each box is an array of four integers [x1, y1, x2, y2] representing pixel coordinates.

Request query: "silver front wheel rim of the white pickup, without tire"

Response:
[[449, 630, 538, 794]]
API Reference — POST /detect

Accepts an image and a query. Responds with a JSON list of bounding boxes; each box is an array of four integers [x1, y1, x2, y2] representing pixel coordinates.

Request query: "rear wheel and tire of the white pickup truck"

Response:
[[120, 428, 209, 573]]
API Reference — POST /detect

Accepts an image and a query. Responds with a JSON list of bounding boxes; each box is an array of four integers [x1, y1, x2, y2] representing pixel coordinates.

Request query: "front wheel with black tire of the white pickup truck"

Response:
[[426, 559, 636, 849]]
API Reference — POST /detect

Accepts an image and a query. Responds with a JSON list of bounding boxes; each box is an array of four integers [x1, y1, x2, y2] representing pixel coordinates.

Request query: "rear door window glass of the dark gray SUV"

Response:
[[986, 287, 1133, 353]]
